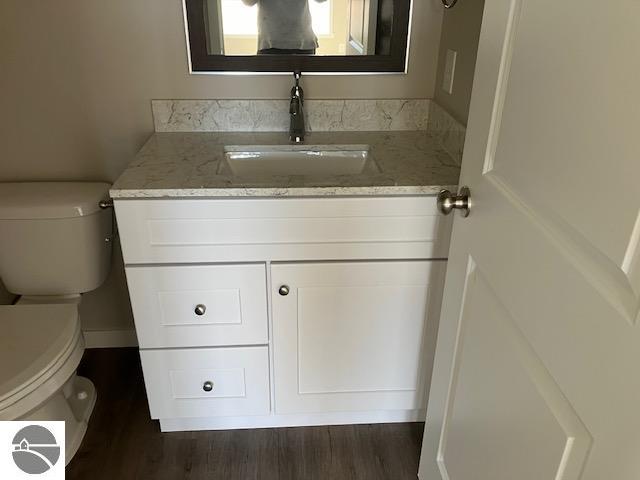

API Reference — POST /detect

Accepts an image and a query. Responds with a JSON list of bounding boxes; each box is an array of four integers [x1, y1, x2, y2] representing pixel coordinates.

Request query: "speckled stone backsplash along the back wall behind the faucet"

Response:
[[152, 99, 431, 132]]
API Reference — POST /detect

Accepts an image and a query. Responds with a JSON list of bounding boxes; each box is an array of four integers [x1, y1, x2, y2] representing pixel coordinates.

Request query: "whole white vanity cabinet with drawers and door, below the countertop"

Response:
[[115, 196, 451, 431]]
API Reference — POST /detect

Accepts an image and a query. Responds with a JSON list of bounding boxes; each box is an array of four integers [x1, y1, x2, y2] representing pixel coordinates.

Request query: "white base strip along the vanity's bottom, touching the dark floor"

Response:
[[160, 410, 426, 432]]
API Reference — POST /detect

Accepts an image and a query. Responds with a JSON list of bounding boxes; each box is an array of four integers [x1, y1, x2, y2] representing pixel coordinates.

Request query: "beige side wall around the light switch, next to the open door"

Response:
[[435, 0, 484, 125]]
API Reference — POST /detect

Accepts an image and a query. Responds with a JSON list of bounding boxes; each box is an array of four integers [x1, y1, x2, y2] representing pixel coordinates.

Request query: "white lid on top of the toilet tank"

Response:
[[0, 182, 111, 220]]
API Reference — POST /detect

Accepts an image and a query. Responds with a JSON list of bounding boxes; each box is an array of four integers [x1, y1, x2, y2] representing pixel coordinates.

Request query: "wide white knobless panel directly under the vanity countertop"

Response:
[[115, 197, 451, 264]]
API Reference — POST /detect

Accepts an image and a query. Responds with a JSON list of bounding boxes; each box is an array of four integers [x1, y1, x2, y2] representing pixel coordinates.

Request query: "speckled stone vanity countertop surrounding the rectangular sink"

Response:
[[111, 131, 460, 198]]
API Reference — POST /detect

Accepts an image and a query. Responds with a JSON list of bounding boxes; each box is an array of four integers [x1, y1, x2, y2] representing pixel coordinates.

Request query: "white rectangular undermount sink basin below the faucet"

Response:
[[218, 145, 380, 176]]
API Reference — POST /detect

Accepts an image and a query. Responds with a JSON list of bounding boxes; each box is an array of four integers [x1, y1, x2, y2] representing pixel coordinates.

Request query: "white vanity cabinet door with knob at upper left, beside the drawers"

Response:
[[271, 261, 445, 414]]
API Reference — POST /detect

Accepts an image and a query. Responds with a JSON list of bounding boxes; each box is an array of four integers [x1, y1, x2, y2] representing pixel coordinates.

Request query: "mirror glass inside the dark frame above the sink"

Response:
[[203, 0, 393, 55]]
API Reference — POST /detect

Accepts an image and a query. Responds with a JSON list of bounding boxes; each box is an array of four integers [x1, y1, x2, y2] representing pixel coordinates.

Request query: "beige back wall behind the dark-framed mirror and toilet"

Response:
[[0, 0, 442, 329]]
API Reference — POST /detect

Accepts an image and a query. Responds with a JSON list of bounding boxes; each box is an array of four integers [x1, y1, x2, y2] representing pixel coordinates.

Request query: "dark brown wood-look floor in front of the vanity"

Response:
[[66, 349, 423, 480]]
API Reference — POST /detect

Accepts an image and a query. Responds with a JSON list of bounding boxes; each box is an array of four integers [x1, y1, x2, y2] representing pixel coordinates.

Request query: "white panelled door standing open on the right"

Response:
[[420, 0, 640, 480]]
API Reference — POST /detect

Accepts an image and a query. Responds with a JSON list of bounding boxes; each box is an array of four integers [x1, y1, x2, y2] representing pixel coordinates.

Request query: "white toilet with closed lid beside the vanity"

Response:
[[0, 182, 113, 463]]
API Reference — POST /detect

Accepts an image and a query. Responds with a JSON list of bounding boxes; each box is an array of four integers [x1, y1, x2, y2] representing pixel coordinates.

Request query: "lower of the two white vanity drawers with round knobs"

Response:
[[140, 347, 270, 418]]
